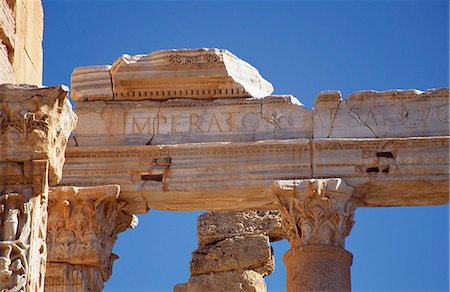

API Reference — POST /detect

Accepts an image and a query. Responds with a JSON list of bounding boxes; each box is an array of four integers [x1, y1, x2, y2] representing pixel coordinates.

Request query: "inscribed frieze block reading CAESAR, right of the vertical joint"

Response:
[[314, 88, 449, 139]]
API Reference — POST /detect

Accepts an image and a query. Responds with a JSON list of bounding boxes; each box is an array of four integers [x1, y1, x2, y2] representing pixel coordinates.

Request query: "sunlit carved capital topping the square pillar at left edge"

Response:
[[0, 84, 77, 182]]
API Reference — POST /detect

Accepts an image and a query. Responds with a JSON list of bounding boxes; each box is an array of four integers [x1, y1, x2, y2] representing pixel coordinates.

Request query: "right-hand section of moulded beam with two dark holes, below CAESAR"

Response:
[[312, 136, 450, 207]]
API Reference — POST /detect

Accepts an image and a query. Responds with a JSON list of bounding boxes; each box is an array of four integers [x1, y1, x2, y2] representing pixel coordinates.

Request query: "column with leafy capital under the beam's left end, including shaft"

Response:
[[45, 185, 137, 292]]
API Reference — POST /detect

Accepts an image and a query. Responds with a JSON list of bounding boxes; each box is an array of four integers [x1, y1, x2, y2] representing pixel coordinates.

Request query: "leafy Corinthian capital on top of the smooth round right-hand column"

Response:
[[273, 178, 355, 248]]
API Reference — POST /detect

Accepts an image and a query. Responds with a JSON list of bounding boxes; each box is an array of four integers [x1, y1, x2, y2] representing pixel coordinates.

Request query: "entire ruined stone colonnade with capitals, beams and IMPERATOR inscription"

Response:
[[0, 1, 450, 292]]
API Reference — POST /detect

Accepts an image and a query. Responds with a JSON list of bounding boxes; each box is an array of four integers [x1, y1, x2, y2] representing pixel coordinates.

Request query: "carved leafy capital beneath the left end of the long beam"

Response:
[[47, 185, 137, 281]]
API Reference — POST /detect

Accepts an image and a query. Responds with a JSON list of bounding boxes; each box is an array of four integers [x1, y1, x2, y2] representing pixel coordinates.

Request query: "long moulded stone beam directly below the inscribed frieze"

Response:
[[62, 137, 450, 213]]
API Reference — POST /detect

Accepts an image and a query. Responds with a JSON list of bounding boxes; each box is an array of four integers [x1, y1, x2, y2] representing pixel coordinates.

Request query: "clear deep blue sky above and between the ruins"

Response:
[[44, 0, 449, 291]]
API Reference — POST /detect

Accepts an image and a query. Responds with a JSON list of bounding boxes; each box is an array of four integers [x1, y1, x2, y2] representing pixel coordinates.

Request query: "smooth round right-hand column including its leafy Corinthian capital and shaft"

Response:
[[274, 178, 355, 292]]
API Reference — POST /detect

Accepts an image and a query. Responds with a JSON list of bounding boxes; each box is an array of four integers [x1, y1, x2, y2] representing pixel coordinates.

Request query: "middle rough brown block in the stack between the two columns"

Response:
[[190, 235, 274, 276]]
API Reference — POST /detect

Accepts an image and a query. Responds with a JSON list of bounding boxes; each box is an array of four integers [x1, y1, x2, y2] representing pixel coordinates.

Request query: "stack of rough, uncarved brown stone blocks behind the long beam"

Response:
[[174, 211, 284, 292]]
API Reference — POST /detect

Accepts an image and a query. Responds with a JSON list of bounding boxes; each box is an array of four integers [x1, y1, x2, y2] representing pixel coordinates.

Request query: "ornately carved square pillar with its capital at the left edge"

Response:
[[0, 84, 77, 292]]
